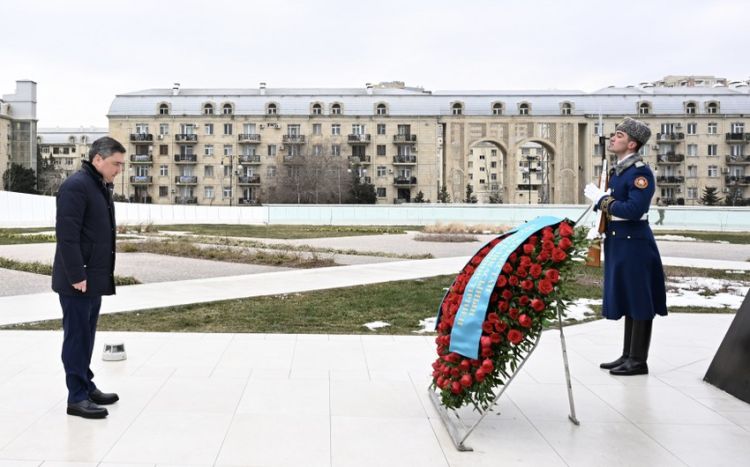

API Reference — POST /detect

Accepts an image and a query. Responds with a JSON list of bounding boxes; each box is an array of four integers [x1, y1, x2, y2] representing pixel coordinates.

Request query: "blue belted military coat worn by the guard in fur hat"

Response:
[[596, 154, 667, 320]]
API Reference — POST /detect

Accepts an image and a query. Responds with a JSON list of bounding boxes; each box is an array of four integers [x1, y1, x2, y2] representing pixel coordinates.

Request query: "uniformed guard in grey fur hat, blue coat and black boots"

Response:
[[584, 118, 667, 376]]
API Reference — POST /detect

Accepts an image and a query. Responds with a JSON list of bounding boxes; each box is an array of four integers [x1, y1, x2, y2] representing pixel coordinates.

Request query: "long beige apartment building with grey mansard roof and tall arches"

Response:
[[108, 77, 750, 205]]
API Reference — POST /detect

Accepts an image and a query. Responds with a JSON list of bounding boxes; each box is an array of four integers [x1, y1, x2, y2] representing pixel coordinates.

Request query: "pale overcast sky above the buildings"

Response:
[[0, 0, 750, 127]]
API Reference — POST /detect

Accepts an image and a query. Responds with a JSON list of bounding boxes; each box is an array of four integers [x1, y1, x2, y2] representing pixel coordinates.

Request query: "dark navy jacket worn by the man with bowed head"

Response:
[[52, 161, 116, 296]]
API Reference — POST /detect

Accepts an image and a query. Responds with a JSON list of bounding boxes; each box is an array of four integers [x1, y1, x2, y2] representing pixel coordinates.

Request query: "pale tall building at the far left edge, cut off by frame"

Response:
[[0, 80, 37, 190]]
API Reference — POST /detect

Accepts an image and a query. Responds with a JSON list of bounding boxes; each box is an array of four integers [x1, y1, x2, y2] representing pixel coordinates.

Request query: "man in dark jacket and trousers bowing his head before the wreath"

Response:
[[52, 137, 125, 418]]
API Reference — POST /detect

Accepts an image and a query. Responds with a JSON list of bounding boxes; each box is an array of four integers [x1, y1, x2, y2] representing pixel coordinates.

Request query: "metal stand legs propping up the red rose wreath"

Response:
[[428, 206, 591, 451]]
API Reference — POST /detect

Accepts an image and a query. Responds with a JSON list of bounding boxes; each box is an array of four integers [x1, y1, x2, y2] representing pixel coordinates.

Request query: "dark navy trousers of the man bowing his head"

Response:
[[60, 295, 102, 403]]
